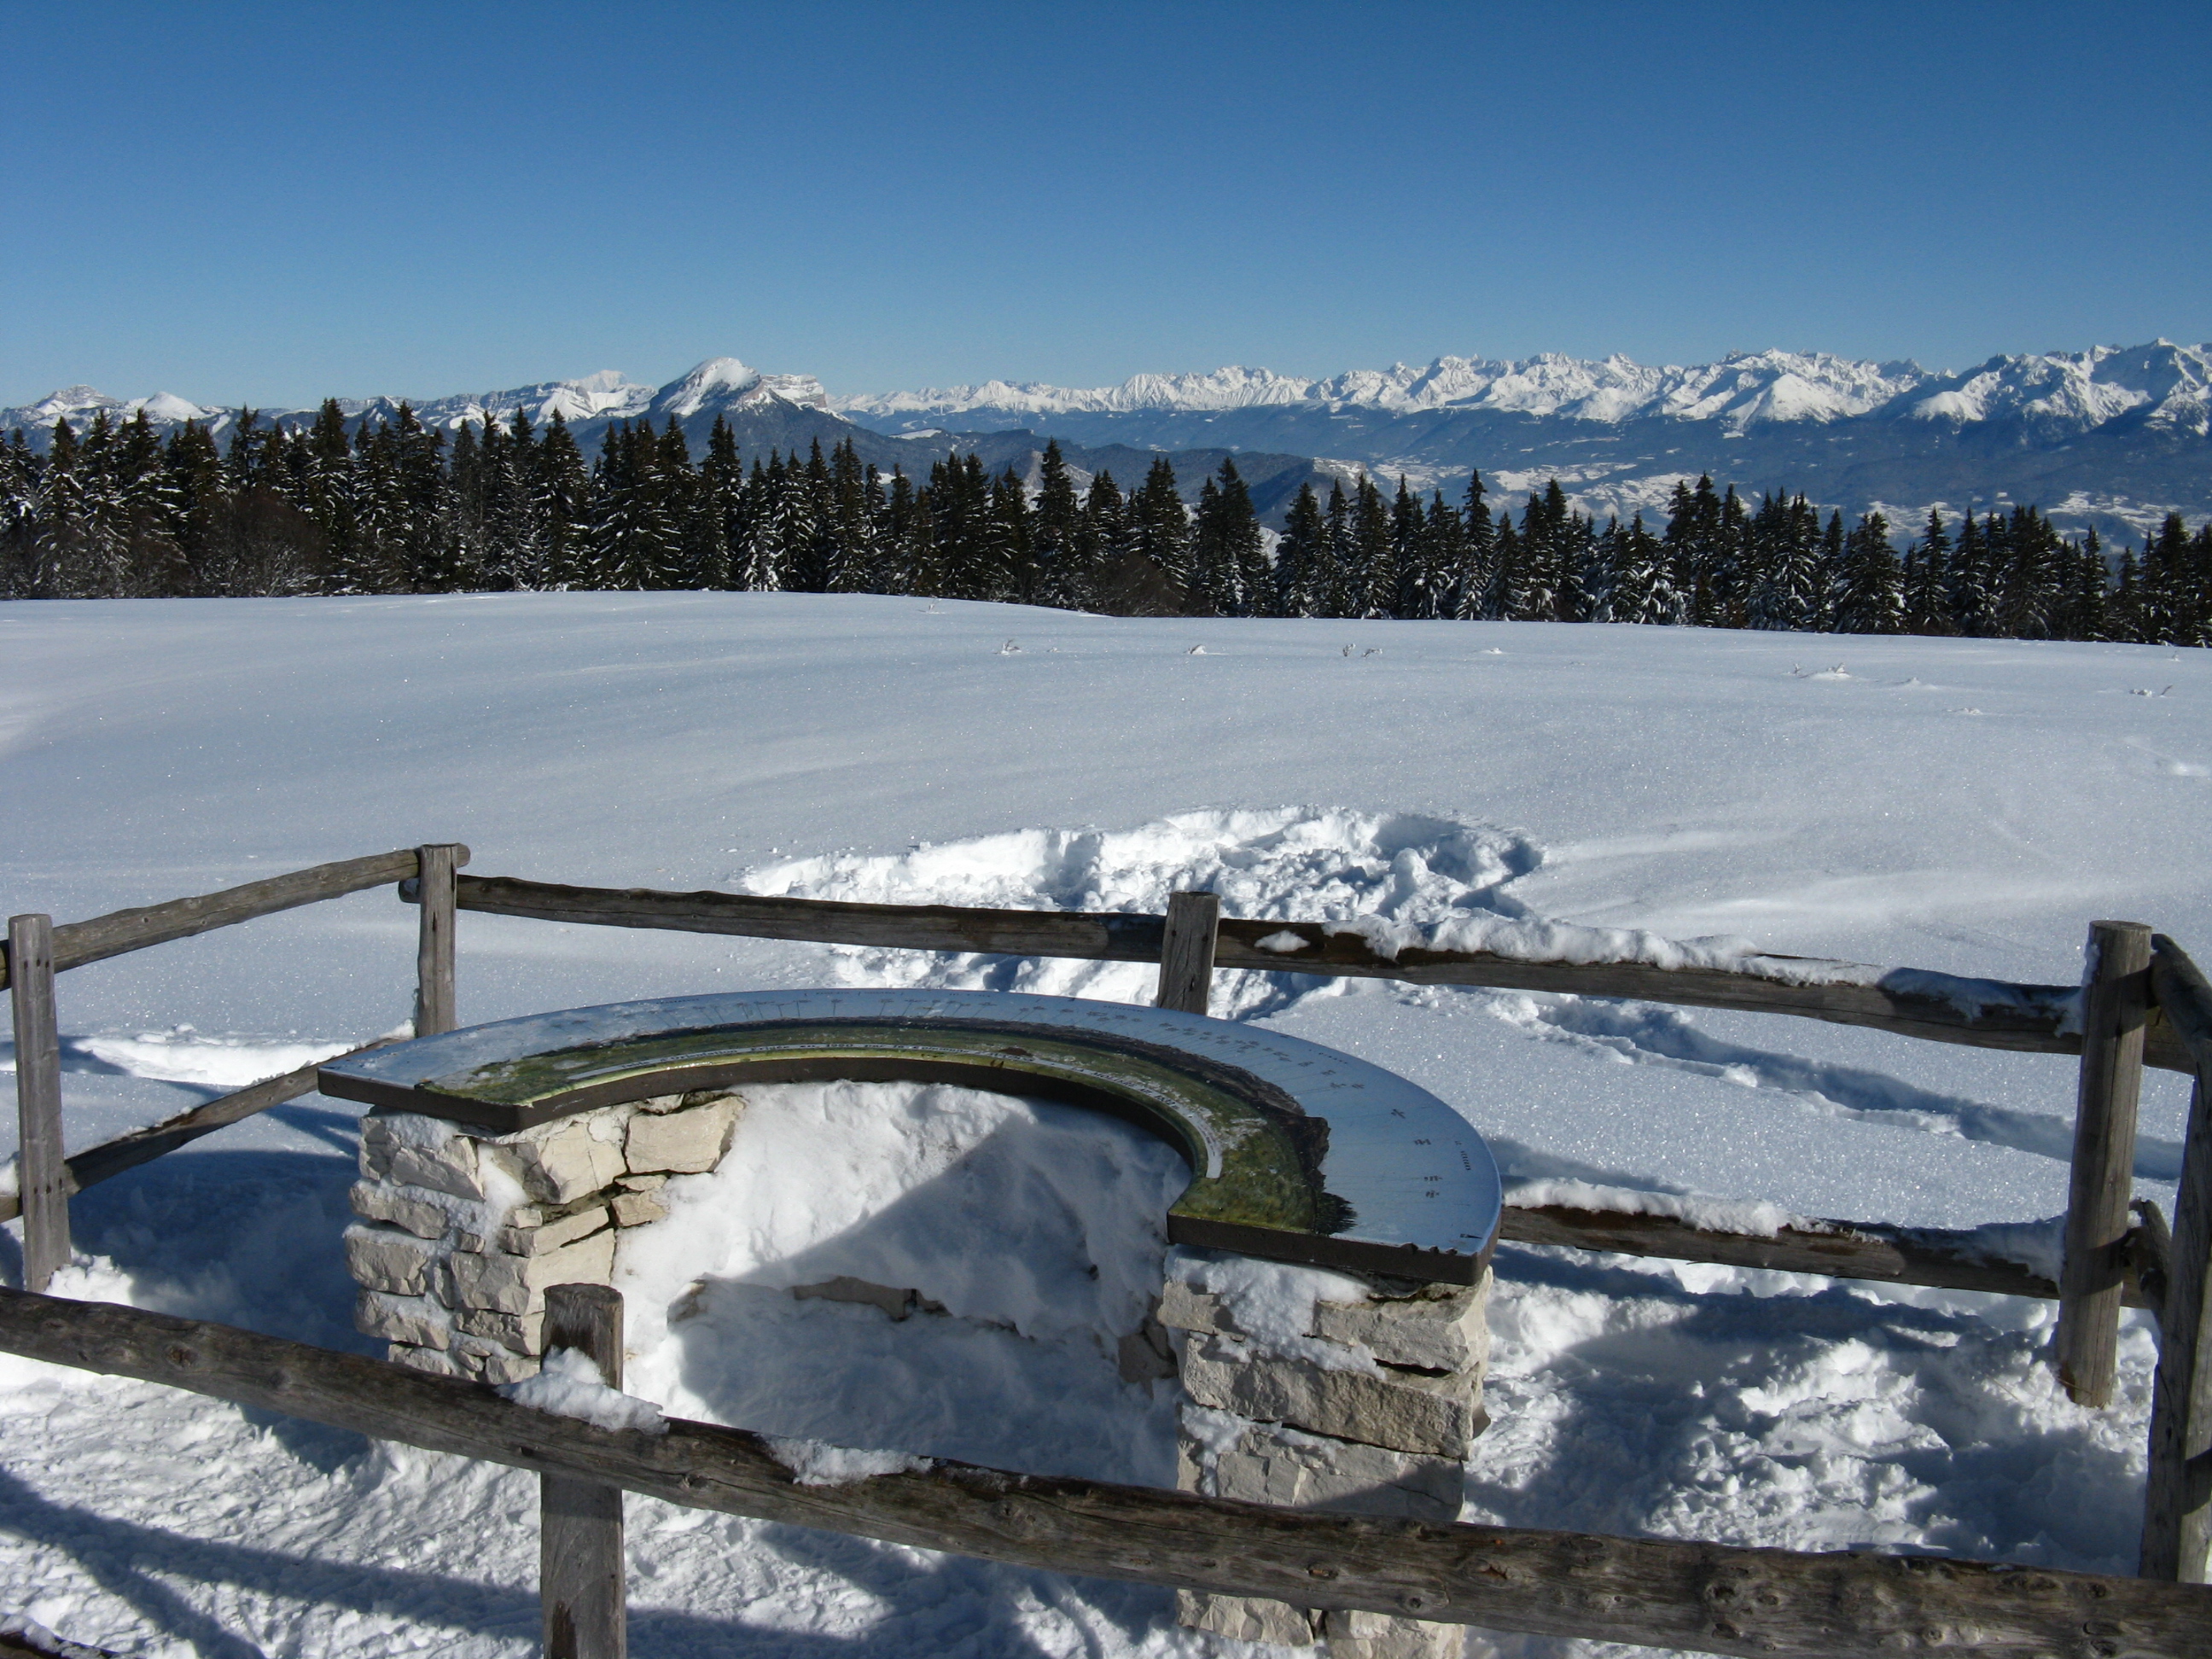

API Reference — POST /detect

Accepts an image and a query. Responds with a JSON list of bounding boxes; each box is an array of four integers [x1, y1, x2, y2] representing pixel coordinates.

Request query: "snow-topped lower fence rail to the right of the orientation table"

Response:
[[1498, 1201, 2159, 1307]]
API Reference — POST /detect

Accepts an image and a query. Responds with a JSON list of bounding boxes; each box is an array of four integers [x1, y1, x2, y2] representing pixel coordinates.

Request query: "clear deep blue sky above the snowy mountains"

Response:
[[0, 0, 2212, 405]]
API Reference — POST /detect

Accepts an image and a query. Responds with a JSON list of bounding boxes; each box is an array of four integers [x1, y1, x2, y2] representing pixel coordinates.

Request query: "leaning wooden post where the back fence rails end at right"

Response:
[[2055, 923, 2150, 1407]]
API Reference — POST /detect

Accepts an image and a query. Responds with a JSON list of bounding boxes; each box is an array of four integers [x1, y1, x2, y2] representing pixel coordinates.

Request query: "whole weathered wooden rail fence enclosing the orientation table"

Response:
[[0, 845, 2212, 1659]]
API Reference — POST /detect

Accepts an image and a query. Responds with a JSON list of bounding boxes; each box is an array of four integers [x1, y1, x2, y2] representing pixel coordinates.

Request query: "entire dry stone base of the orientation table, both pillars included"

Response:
[[345, 1091, 1488, 1659]]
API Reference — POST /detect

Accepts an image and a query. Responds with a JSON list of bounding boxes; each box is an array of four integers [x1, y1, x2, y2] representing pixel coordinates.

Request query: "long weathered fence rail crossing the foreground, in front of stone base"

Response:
[[0, 1289, 2212, 1659]]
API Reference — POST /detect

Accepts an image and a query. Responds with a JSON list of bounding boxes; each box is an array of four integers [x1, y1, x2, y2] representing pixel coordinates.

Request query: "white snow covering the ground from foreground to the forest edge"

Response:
[[0, 595, 2212, 1659]]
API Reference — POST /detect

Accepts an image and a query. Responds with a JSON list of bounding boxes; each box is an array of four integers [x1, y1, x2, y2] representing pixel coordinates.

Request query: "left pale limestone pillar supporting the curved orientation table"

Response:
[[345, 1091, 746, 1382]]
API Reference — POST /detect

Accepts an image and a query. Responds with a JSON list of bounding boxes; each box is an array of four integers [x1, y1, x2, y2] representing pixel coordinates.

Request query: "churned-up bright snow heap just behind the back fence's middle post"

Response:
[[732, 807, 1544, 1020]]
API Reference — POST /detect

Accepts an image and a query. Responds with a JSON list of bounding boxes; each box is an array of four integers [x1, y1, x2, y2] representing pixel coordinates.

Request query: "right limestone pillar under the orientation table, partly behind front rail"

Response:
[[1159, 1252, 1491, 1659]]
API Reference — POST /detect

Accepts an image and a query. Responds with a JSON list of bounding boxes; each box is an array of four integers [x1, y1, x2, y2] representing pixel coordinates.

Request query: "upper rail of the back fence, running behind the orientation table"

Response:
[[427, 876, 2187, 1071]]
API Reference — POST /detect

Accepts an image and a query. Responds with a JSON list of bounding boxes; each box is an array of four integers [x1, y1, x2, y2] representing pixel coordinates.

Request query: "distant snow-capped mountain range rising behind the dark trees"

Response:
[[0, 341, 2212, 539]]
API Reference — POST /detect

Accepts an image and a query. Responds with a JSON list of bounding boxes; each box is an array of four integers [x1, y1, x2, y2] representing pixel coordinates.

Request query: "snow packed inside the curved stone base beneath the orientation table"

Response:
[[615, 1081, 1190, 1484]]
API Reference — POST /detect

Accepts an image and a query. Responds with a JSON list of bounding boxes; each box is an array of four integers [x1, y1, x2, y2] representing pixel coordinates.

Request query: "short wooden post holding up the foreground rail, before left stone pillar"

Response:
[[538, 1285, 631, 1659]]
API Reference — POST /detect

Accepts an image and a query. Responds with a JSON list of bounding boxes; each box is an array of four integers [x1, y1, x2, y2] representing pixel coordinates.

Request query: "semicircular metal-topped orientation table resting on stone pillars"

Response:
[[318, 991, 1499, 1285]]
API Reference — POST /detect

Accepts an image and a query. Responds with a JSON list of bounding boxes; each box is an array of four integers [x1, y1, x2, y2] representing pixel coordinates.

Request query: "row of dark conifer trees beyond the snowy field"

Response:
[[0, 403, 2212, 646]]
